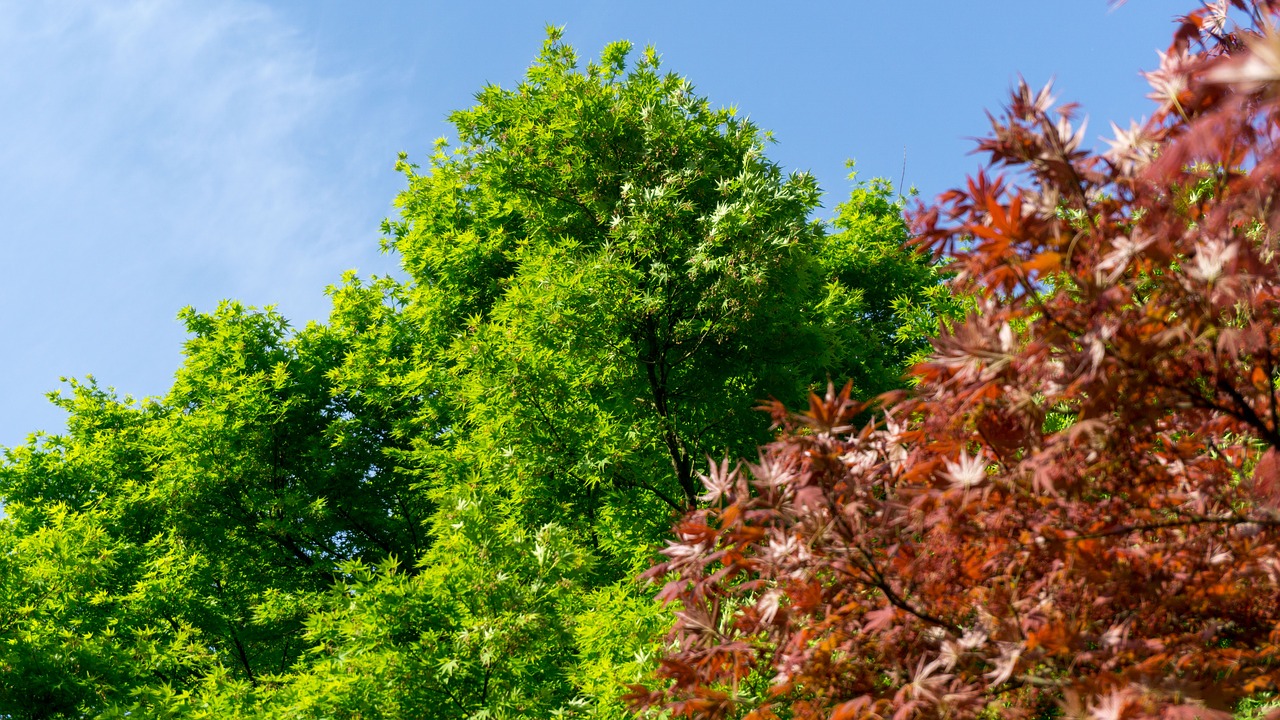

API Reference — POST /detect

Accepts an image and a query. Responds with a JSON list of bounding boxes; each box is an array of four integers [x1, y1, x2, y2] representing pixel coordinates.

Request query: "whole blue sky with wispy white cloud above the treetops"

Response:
[[0, 0, 1177, 445]]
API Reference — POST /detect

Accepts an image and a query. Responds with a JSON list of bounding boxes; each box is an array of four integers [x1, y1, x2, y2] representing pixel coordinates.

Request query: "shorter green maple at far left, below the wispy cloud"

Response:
[[0, 297, 433, 717]]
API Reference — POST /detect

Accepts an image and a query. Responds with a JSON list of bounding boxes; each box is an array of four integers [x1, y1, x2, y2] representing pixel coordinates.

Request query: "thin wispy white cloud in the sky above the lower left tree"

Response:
[[0, 0, 392, 443]]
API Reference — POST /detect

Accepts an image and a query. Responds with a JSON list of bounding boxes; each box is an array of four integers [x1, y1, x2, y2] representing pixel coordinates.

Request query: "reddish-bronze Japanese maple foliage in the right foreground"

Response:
[[632, 0, 1280, 720]]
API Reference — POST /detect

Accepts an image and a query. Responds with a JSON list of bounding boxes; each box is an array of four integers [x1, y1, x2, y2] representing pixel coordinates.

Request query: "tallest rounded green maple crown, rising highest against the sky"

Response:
[[388, 29, 938, 566]]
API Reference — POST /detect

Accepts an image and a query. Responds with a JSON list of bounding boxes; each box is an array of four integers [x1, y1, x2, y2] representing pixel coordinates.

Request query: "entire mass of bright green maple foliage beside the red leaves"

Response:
[[0, 29, 959, 719]]
